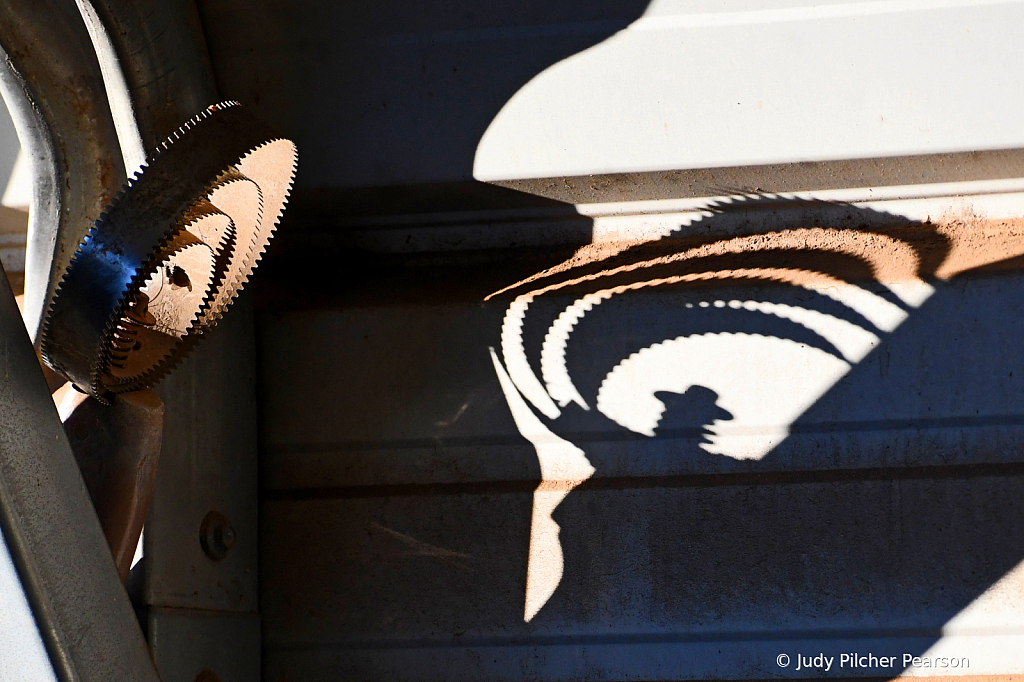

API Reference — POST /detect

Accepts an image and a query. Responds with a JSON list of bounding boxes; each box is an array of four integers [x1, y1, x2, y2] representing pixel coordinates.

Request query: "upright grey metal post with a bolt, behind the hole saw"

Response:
[[78, 0, 260, 682]]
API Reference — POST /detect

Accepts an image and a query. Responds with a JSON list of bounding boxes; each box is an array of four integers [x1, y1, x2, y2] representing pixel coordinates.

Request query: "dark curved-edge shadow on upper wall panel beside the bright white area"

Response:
[[199, 0, 648, 218]]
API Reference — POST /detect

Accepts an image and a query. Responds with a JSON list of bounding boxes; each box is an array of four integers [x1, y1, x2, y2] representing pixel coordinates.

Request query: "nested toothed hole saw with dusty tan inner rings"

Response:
[[41, 102, 298, 397]]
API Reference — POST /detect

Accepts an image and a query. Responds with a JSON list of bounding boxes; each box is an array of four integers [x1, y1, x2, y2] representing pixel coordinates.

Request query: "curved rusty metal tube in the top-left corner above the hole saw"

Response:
[[0, 0, 126, 342]]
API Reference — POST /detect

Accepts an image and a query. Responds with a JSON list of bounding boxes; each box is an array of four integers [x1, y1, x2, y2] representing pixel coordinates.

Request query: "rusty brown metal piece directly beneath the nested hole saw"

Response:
[[58, 387, 164, 583]]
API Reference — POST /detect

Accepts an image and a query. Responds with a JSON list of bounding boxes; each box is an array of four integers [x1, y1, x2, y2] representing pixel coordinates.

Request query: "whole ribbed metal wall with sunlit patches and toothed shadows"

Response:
[[200, 0, 1024, 681]]
